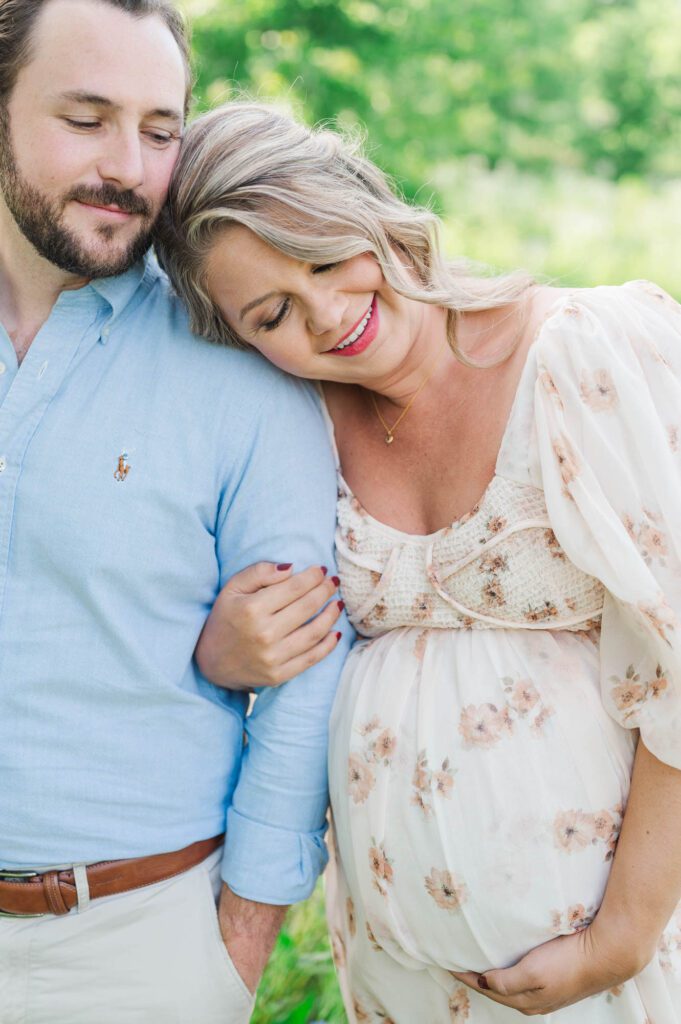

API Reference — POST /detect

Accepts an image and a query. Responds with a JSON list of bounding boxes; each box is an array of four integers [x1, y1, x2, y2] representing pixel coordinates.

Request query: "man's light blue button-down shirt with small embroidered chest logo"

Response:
[[0, 253, 350, 903]]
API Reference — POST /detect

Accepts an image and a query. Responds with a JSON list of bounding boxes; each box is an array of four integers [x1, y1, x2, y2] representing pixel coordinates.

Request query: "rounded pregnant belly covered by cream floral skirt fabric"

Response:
[[330, 629, 636, 970]]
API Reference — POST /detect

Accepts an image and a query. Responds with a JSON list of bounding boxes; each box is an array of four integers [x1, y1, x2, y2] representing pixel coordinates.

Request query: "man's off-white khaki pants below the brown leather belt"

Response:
[[0, 850, 254, 1024]]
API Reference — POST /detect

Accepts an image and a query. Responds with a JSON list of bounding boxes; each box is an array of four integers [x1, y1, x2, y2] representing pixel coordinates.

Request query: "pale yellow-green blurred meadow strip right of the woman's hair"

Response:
[[436, 160, 681, 297]]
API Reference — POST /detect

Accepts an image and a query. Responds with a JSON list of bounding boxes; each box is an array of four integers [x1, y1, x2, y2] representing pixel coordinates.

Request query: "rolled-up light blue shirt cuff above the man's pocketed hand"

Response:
[[222, 807, 329, 906]]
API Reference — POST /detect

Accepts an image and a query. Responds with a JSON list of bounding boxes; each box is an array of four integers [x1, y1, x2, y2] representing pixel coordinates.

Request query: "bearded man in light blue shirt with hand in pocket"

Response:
[[0, 0, 345, 1024]]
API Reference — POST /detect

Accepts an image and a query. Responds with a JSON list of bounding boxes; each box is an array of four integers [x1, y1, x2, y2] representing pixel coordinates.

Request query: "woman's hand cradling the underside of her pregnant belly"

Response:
[[453, 916, 654, 1017]]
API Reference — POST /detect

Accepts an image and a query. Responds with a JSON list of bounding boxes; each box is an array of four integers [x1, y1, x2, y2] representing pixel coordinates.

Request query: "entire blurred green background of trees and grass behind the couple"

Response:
[[182, 0, 681, 1024]]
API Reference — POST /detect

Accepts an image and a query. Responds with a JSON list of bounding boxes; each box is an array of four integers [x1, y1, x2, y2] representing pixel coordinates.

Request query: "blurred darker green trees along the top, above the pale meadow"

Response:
[[184, 0, 681, 195]]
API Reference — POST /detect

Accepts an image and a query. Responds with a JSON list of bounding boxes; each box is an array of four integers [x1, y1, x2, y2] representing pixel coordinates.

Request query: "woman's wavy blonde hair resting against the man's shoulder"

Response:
[[156, 101, 533, 365]]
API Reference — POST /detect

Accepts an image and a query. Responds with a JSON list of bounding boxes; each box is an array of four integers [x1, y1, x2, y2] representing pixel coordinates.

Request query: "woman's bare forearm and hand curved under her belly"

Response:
[[457, 741, 681, 1016]]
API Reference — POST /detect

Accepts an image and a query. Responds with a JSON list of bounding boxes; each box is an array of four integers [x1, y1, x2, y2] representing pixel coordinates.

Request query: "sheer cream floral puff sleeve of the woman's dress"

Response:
[[535, 282, 681, 768]]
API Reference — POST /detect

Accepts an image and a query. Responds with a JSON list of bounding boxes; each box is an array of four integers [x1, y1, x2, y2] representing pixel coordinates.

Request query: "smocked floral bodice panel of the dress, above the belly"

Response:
[[336, 475, 603, 637]]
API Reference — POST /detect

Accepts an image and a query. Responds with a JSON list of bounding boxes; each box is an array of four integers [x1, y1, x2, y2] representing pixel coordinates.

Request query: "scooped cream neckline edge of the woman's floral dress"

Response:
[[315, 286, 577, 544]]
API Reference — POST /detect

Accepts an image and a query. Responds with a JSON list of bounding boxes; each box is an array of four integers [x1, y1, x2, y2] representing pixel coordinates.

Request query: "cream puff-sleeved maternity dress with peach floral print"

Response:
[[321, 282, 681, 1024]]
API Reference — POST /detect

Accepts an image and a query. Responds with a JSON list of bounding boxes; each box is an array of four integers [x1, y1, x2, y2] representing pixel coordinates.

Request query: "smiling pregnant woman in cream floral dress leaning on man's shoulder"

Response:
[[160, 103, 681, 1024]]
